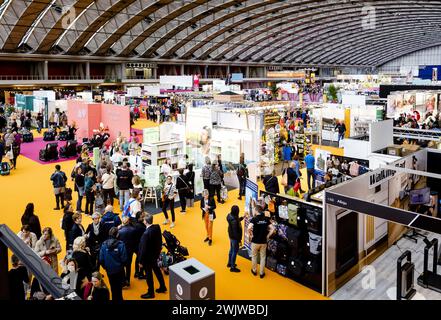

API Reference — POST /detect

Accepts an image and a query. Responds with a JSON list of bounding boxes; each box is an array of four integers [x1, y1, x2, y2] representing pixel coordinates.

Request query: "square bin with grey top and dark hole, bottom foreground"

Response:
[[169, 258, 215, 300]]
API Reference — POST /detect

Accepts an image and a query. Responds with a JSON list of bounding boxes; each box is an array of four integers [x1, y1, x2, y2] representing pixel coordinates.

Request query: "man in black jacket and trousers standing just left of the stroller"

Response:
[[139, 214, 167, 299]]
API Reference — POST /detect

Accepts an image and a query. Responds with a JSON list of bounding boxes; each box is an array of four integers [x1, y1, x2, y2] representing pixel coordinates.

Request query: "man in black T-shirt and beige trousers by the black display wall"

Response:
[[247, 205, 274, 279]]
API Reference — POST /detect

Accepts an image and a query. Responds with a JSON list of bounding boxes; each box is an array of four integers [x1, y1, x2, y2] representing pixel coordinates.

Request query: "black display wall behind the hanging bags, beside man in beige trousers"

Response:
[[260, 191, 323, 293]]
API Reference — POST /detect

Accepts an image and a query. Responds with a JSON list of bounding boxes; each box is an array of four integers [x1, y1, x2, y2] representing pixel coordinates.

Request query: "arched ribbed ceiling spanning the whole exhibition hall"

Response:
[[0, 0, 441, 66]]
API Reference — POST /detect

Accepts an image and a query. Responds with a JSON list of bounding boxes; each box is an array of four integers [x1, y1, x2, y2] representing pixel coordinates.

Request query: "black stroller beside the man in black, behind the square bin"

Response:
[[158, 230, 188, 274]]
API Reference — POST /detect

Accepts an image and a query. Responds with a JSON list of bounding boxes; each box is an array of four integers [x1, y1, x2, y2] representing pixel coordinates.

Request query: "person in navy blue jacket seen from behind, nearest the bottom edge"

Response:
[[99, 227, 127, 301]]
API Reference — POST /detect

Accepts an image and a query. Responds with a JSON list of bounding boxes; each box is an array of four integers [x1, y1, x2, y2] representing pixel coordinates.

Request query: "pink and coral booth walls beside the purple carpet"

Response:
[[67, 100, 130, 142]]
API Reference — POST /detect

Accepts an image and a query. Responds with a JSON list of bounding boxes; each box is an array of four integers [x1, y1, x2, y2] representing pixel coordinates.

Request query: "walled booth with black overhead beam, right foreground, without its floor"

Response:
[[324, 149, 441, 296]]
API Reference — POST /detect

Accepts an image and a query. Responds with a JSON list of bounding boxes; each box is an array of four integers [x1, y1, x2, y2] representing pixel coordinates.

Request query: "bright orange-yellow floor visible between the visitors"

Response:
[[0, 120, 324, 300]]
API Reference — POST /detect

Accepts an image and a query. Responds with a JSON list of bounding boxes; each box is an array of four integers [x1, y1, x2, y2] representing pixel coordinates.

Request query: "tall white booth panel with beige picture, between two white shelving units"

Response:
[[185, 107, 213, 168]]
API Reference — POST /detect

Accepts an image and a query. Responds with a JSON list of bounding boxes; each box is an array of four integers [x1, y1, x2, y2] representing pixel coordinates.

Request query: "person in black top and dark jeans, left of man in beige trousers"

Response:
[[227, 205, 243, 272]]
